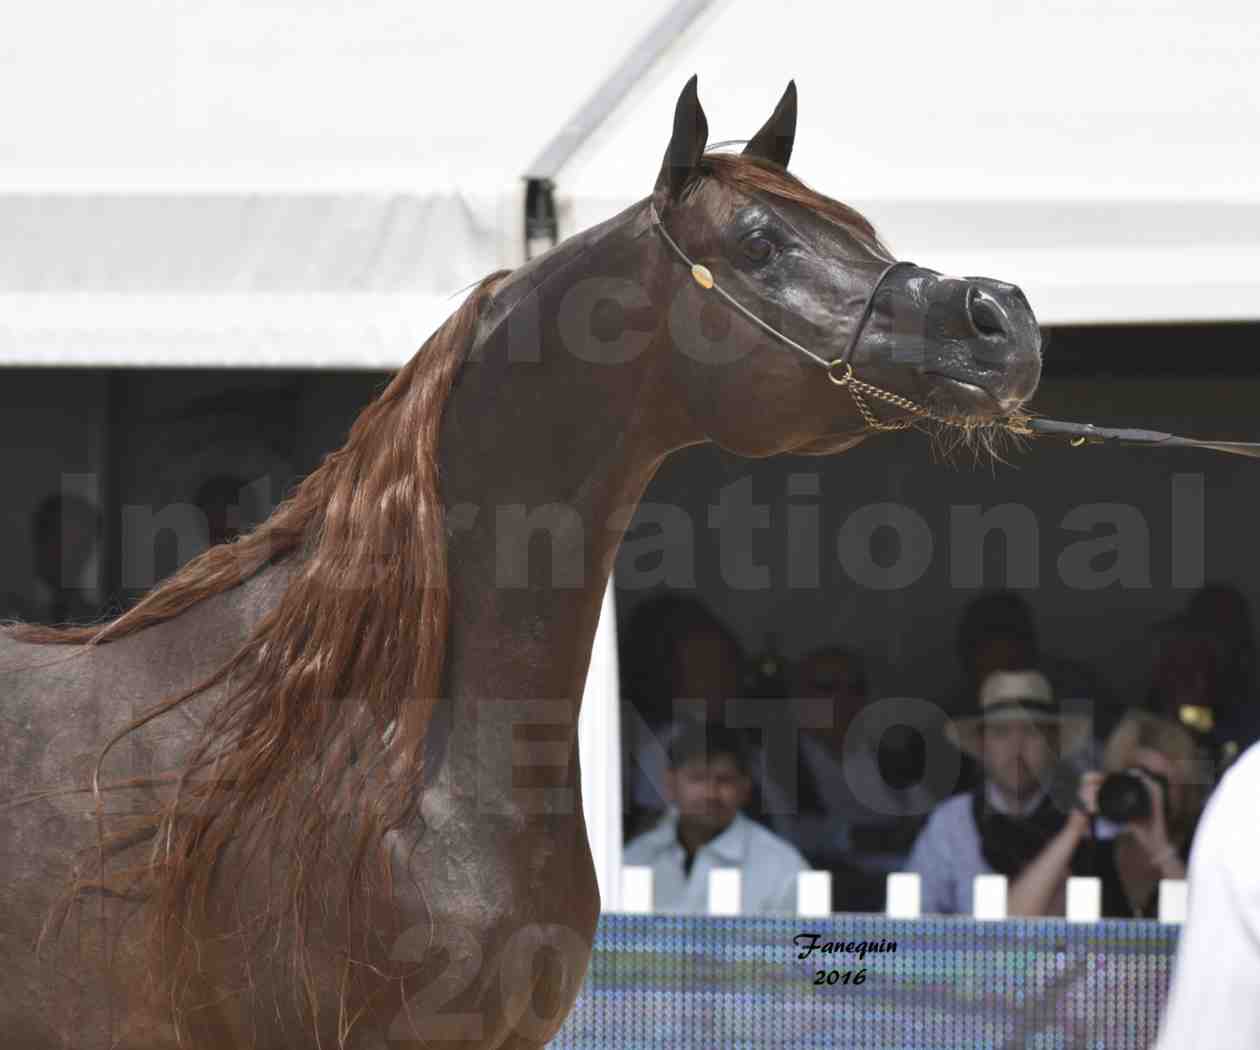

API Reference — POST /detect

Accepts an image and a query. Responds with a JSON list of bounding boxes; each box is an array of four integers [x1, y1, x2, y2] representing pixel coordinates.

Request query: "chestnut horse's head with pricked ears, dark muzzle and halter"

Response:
[[648, 77, 1041, 456]]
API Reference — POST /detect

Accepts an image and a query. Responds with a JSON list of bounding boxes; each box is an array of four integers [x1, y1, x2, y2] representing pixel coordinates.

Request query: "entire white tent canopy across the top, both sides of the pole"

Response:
[[9, 0, 1260, 367]]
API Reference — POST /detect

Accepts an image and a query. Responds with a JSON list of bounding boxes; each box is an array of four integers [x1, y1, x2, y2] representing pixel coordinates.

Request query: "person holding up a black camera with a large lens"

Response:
[[1007, 711, 1211, 919]]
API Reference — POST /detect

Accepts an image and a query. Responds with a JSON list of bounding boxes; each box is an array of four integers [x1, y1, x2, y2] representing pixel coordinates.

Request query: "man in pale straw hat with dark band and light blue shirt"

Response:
[[908, 671, 1090, 915]]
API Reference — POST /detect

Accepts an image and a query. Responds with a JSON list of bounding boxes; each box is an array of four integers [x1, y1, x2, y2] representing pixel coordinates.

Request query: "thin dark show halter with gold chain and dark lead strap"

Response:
[[648, 203, 1260, 459]]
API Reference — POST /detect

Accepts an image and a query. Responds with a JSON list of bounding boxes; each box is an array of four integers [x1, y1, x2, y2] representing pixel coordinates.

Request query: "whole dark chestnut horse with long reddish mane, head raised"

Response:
[[0, 77, 1041, 1050]]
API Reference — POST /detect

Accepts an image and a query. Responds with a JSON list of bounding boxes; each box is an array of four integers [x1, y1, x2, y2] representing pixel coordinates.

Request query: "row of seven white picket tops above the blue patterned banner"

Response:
[[620, 867, 1186, 923]]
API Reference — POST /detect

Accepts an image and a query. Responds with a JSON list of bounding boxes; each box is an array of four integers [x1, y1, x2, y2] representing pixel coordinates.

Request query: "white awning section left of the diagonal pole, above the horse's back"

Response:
[[0, 0, 670, 368]]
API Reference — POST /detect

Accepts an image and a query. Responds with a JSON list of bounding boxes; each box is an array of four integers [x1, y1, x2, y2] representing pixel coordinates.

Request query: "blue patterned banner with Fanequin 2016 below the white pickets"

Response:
[[549, 915, 1181, 1050]]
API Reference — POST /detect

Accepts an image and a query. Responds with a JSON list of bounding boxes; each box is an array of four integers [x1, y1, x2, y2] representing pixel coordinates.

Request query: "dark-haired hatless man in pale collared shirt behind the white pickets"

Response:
[[624, 722, 810, 915]]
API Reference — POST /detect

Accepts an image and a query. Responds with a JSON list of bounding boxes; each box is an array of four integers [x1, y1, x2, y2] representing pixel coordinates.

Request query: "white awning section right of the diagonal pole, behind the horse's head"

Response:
[[556, 0, 1260, 324]]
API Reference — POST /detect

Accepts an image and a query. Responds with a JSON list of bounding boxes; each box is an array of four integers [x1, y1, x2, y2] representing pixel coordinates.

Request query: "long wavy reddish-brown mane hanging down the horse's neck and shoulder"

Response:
[[5, 270, 509, 1035]]
